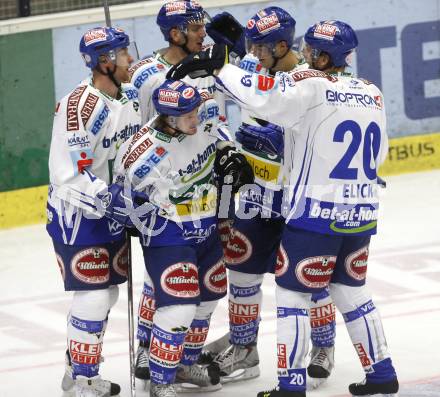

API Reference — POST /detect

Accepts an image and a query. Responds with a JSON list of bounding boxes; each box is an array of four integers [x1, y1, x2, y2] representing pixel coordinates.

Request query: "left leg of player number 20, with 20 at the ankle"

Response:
[[259, 226, 341, 397]]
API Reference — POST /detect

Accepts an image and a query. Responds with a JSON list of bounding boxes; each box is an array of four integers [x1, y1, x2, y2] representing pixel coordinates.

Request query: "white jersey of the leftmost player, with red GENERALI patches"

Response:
[[47, 79, 141, 245]]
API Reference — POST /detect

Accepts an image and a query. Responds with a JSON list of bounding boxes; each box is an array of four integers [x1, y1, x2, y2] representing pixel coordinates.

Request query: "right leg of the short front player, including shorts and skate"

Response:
[[176, 233, 227, 392]]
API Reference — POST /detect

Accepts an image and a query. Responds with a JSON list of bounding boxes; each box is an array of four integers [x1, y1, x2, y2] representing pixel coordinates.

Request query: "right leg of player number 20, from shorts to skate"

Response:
[[330, 237, 399, 396]]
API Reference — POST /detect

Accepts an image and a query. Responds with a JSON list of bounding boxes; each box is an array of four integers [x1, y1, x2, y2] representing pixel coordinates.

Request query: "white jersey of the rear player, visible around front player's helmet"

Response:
[[130, 48, 228, 132]]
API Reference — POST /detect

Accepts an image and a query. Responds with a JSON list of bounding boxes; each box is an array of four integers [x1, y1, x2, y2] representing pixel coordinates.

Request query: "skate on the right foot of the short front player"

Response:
[[176, 364, 222, 393]]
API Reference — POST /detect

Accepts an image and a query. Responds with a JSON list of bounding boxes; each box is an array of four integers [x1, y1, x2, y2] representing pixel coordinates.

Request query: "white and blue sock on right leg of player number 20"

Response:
[[330, 284, 396, 383]]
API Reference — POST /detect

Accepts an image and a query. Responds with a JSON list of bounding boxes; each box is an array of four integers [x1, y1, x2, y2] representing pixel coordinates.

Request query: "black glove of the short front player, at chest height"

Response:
[[214, 145, 254, 193]]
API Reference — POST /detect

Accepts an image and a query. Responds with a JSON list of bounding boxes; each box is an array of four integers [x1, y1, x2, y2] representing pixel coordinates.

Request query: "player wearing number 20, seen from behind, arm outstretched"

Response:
[[170, 21, 399, 397]]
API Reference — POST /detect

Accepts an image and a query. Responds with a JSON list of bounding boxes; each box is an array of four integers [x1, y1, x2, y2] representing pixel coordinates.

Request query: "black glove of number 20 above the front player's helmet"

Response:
[[167, 44, 229, 80]]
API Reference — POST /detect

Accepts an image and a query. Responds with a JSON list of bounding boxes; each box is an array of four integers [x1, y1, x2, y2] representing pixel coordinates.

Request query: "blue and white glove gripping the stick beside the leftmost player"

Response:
[[95, 183, 148, 227]]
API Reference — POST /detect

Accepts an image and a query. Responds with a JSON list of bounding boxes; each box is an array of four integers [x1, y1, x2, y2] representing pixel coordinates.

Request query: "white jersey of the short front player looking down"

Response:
[[115, 90, 229, 246]]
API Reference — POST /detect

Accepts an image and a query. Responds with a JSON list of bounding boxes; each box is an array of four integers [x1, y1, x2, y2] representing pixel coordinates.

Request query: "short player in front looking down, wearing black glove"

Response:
[[115, 81, 252, 397]]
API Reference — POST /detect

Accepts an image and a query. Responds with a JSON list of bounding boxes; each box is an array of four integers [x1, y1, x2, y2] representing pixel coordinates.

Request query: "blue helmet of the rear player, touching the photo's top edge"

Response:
[[156, 0, 209, 41]]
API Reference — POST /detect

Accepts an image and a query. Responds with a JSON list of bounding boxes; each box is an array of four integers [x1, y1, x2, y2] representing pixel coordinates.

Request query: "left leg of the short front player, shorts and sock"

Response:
[[143, 246, 200, 397]]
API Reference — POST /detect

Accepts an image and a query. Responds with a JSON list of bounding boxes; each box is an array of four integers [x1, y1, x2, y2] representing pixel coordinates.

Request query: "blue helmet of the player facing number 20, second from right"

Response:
[[245, 7, 296, 52]]
